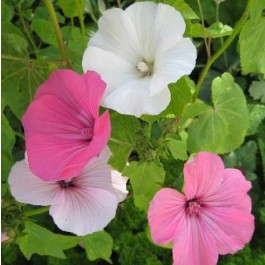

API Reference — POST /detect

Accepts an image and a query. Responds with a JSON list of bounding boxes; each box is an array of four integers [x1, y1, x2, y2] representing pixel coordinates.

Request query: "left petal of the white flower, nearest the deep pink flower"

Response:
[[82, 46, 137, 96]]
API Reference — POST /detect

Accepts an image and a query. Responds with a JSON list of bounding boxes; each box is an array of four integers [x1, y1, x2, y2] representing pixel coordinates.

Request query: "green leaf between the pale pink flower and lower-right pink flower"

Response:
[[122, 162, 165, 210]]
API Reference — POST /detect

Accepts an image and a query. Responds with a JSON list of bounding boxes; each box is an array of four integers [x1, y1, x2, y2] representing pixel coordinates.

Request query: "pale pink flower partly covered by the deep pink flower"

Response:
[[8, 148, 127, 236]]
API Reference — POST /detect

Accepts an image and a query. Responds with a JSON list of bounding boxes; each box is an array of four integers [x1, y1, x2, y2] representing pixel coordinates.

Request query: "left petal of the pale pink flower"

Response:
[[8, 160, 61, 205]]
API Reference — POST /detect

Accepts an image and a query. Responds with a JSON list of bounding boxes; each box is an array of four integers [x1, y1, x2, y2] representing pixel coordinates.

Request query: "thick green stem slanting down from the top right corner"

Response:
[[193, 4, 249, 101]]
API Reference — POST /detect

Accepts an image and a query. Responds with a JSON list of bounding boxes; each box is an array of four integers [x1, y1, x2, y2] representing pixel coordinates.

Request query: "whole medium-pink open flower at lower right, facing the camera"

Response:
[[148, 152, 254, 265]]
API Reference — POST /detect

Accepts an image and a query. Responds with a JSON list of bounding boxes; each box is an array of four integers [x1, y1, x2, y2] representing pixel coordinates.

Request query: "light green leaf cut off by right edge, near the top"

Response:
[[239, 17, 265, 74]]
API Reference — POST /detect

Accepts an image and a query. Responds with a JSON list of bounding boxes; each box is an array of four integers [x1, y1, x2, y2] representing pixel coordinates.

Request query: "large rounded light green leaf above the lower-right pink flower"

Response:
[[186, 73, 249, 154]]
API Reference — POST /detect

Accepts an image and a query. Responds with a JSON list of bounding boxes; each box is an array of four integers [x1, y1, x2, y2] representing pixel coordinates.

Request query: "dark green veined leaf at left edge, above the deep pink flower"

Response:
[[2, 33, 51, 119]]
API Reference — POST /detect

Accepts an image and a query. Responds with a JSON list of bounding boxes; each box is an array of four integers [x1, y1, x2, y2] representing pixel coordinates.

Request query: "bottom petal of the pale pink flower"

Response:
[[50, 187, 118, 236]]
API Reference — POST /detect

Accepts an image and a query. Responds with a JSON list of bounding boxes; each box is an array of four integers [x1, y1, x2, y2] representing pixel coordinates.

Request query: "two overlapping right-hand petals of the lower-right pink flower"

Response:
[[202, 169, 254, 254]]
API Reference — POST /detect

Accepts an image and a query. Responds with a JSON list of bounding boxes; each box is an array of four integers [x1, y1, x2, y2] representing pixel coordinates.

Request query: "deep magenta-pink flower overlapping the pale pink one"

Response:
[[23, 70, 111, 180]]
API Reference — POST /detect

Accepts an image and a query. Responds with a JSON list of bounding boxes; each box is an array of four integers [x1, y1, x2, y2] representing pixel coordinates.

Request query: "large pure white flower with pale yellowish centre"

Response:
[[82, 2, 197, 117]]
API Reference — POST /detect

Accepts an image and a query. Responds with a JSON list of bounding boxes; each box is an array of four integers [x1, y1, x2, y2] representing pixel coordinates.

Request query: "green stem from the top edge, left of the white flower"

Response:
[[44, 0, 71, 68]]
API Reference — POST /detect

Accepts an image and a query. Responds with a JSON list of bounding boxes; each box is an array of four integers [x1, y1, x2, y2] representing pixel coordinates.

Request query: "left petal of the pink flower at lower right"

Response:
[[148, 188, 185, 244]]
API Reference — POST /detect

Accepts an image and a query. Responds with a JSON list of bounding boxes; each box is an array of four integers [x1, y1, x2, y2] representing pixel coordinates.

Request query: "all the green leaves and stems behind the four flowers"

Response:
[[1, 0, 265, 265]]
